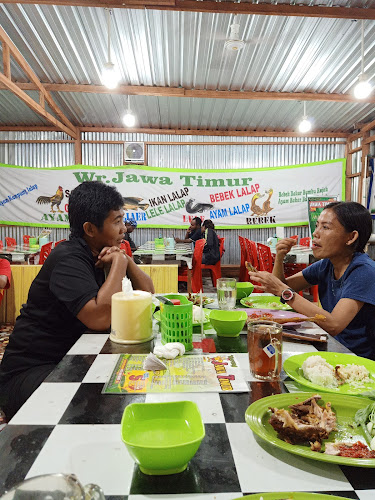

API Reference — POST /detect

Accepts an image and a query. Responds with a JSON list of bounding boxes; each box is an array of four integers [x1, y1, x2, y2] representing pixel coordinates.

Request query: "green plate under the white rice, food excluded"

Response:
[[283, 352, 375, 395]]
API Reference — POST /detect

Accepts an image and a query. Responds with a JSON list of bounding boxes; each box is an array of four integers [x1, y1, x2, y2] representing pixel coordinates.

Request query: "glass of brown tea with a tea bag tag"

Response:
[[247, 320, 283, 380]]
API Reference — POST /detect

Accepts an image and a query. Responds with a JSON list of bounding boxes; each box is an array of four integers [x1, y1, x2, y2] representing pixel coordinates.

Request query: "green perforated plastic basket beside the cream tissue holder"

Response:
[[160, 294, 193, 351]]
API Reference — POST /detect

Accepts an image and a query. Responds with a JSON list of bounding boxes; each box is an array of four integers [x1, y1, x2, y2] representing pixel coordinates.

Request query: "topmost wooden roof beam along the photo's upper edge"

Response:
[[2, 0, 375, 19]]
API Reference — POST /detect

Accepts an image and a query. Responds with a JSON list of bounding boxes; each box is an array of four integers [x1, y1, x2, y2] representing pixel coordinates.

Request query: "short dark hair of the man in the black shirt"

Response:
[[68, 181, 124, 238]]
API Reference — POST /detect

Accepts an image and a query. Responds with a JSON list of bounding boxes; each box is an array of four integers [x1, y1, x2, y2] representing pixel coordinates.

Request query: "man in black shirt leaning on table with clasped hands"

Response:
[[0, 181, 154, 420]]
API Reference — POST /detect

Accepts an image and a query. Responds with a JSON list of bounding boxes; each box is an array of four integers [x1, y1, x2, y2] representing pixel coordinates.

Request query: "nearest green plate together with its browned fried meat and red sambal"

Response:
[[245, 392, 375, 467]]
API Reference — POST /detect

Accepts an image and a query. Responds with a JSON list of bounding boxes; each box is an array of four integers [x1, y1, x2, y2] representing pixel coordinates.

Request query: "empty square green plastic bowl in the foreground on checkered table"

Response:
[[121, 401, 205, 475]]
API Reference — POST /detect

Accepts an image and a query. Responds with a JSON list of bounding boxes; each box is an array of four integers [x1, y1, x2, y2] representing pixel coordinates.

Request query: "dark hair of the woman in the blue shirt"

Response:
[[324, 201, 372, 252]]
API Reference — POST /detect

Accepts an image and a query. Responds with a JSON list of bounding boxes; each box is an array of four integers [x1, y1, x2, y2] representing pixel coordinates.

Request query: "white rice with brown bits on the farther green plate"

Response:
[[302, 356, 371, 388]]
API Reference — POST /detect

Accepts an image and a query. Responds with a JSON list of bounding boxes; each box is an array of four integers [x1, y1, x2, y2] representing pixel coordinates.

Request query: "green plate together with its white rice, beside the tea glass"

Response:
[[284, 352, 375, 395]]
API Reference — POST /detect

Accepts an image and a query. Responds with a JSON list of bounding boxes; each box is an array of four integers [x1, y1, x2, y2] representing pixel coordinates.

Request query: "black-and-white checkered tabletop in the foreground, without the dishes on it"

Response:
[[0, 294, 375, 500]]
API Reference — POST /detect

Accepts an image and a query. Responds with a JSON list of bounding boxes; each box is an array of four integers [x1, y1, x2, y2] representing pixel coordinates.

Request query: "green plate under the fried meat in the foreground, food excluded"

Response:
[[245, 392, 375, 467]]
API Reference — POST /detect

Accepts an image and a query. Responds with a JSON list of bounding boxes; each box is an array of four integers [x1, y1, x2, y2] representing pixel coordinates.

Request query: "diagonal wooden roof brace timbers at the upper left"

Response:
[[0, 26, 77, 138]]
